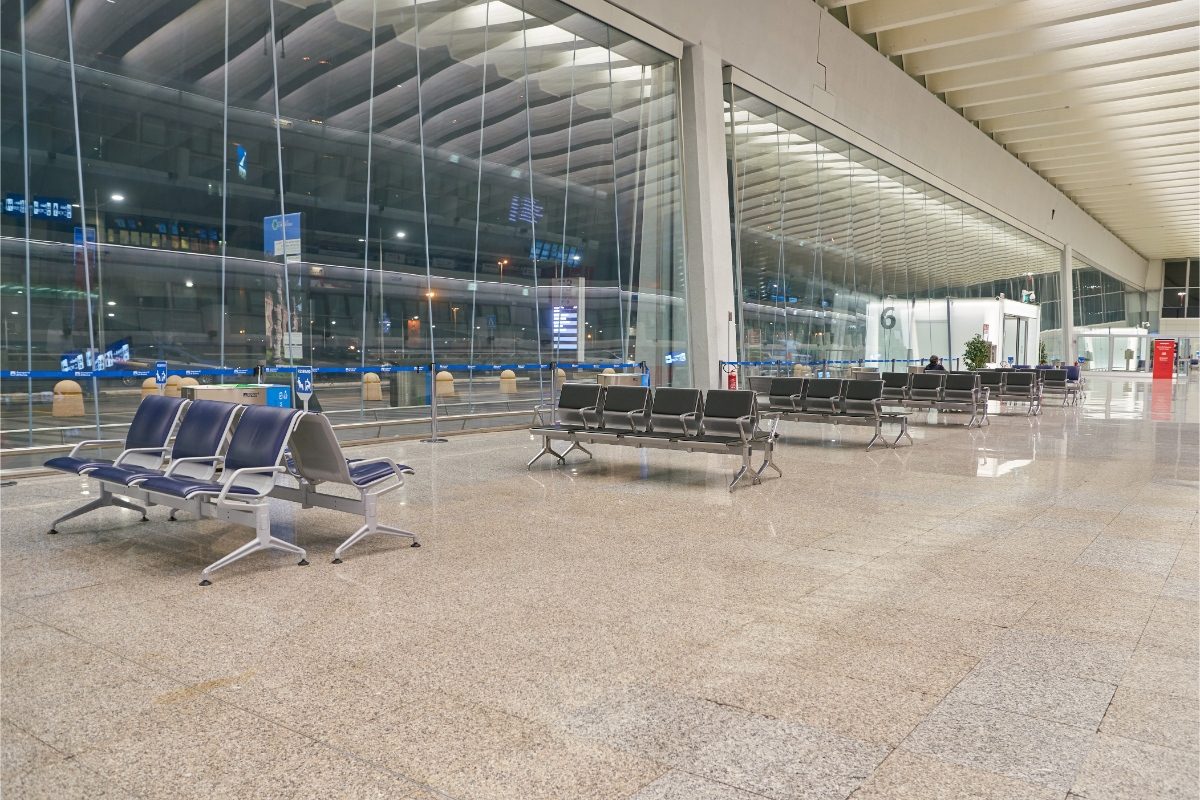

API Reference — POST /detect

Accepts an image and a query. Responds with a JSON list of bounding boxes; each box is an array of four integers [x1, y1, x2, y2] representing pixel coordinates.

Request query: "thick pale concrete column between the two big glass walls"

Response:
[[680, 44, 737, 389]]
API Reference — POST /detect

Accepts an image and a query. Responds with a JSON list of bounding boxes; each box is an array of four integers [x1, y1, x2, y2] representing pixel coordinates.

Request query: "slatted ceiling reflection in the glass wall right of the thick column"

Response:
[[726, 97, 1058, 287]]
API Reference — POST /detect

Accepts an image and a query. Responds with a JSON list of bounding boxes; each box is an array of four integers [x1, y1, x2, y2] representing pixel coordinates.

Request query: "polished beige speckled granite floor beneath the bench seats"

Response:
[[0, 377, 1200, 800]]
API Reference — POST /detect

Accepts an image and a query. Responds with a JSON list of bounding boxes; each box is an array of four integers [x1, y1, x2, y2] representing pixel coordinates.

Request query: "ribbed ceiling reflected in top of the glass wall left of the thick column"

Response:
[[11, 0, 676, 199]]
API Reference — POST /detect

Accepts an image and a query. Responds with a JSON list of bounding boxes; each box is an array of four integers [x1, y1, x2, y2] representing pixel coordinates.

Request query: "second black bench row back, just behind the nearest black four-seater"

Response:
[[750, 378, 912, 450]]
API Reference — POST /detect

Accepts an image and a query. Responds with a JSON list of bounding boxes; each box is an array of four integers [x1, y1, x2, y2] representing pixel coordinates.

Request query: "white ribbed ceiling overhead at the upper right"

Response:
[[817, 0, 1200, 258]]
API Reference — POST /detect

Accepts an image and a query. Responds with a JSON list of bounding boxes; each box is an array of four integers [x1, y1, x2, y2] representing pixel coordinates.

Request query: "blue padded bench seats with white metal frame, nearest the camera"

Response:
[[46, 396, 419, 585]]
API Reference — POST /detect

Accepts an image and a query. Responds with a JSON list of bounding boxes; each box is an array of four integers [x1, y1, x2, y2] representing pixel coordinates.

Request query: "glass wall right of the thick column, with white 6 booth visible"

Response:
[[726, 85, 1061, 368]]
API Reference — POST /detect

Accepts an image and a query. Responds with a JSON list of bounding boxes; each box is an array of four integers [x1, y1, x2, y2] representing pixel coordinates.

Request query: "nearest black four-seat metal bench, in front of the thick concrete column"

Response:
[[528, 383, 782, 491]]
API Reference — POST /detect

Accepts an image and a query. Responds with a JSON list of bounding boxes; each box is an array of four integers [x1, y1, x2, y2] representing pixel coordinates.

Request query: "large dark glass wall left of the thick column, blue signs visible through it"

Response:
[[0, 0, 689, 444]]
